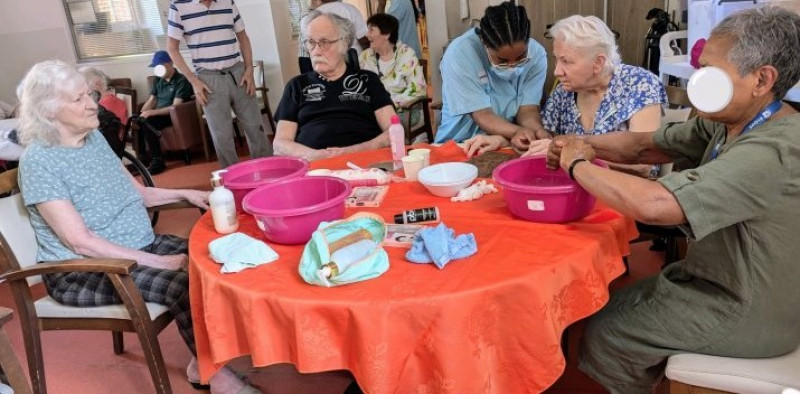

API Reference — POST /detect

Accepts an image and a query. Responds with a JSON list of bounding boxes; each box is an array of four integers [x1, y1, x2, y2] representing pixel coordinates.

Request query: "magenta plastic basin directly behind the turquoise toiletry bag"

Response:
[[242, 176, 352, 245]]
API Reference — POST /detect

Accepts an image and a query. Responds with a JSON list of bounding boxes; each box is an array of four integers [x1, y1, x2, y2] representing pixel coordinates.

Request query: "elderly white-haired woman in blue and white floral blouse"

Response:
[[511, 15, 667, 176]]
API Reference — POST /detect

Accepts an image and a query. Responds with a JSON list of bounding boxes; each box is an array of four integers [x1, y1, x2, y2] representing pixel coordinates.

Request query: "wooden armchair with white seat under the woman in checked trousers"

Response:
[[0, 171, 191, 394]]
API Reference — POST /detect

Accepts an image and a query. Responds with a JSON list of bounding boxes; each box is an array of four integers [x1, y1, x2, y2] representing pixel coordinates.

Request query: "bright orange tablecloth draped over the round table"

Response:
[[189, 145, 636, 394]]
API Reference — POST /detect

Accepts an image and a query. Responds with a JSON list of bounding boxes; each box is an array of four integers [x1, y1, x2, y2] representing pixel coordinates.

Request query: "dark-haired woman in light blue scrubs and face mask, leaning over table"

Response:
[[436, 1, 547, 155]]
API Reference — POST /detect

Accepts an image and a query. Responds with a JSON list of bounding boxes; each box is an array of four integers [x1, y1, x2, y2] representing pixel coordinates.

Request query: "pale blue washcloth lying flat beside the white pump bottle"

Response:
[[208, 233, 278, 273]]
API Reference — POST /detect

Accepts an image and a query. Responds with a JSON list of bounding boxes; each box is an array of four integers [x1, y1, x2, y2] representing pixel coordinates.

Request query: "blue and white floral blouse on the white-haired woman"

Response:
[[542, 64, 667, 134]]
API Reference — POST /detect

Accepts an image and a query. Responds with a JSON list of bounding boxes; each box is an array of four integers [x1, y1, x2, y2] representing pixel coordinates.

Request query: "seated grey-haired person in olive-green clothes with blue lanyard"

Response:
[[548, 7, 800, 394]]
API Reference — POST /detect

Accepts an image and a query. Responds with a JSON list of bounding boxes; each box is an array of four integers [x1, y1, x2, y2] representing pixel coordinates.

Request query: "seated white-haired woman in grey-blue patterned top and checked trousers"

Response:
[[17, 61, 250, 393]]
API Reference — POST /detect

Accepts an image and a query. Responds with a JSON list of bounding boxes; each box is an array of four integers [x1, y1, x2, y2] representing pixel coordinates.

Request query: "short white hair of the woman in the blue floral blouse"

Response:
[[550, 15, 622, 73]]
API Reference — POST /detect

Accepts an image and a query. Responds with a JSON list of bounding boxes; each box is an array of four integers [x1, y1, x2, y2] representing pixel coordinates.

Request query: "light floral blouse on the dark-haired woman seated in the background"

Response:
[[358, 42, 427, 125]]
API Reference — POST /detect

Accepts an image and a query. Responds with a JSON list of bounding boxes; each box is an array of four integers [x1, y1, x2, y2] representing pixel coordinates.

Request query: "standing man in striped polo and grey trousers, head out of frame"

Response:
[[167, 0, 272, 168]]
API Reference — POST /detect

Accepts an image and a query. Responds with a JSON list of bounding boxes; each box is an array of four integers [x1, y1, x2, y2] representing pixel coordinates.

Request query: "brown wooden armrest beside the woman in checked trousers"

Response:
[[0, 259, 136, 282]]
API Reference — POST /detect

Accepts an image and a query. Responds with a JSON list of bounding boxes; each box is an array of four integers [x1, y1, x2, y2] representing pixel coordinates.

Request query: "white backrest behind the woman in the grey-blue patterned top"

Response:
[[0, 193, 41, 283]]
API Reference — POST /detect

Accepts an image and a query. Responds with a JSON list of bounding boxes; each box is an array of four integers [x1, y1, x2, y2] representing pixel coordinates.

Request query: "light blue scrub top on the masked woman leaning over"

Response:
[[435, 29, 547, 143]]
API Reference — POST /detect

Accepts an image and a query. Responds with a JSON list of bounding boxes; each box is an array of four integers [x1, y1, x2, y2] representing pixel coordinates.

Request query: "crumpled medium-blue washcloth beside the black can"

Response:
[[406, 223, 478, 269]]
